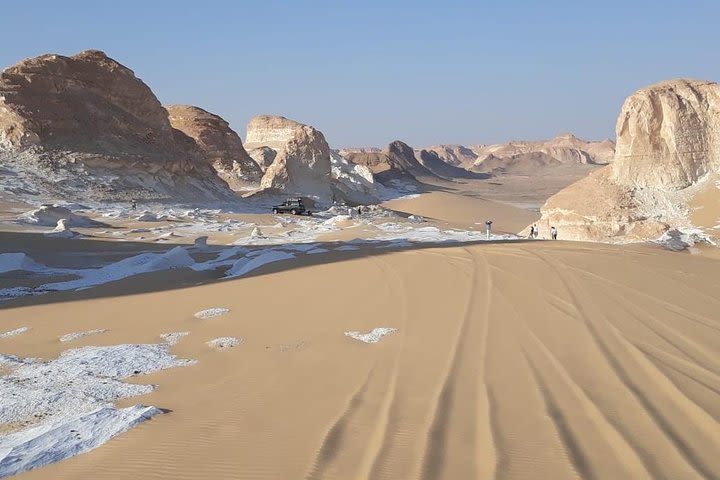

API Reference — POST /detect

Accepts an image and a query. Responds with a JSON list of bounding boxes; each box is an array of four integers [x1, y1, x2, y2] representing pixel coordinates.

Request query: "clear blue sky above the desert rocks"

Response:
[[0, 0, 720, 147]]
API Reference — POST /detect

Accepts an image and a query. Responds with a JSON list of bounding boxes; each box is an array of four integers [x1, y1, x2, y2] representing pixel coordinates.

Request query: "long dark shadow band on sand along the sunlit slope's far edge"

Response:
[[0, 232, 524, 309]]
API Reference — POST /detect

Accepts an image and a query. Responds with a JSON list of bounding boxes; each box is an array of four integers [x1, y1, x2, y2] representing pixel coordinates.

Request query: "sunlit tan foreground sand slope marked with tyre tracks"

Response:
[[0, 242, 720, 479]]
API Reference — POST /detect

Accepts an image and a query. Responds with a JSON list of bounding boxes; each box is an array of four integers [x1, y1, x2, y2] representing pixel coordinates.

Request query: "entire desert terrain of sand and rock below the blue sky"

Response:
[[0, 50, 720, 480]]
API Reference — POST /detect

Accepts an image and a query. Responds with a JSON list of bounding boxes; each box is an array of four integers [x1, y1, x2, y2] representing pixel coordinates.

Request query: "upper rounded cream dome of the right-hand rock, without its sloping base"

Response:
[[613, 80, 720, 190]]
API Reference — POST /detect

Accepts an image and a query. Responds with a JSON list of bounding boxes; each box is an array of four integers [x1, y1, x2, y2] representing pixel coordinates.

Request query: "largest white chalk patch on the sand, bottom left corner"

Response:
[[0, 344, 195, 477]]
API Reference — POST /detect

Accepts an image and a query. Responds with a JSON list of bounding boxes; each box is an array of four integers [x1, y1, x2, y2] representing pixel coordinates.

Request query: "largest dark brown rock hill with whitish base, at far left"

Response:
[[0, 50, 232, 200]]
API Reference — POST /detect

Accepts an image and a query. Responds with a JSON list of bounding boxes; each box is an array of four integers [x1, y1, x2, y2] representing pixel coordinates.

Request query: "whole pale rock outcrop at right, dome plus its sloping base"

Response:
[[540, 80, 720, 242]]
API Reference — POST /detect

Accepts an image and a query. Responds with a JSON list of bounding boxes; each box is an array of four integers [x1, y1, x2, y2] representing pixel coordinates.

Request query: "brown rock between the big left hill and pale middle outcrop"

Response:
[[165, 105, 263, 190]]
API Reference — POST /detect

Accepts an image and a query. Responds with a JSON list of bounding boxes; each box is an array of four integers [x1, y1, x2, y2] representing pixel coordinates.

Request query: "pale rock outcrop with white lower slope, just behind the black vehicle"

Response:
[[246, 115, 381, 204]]
